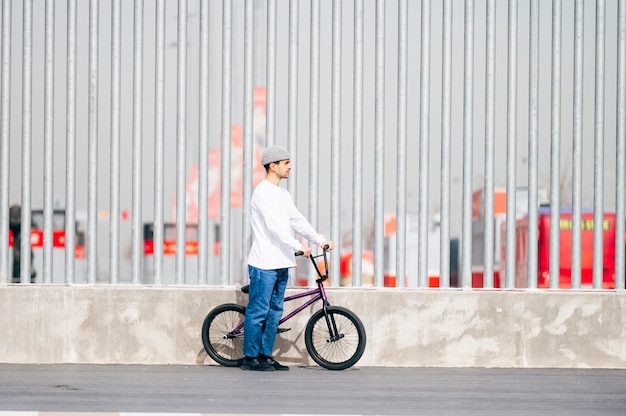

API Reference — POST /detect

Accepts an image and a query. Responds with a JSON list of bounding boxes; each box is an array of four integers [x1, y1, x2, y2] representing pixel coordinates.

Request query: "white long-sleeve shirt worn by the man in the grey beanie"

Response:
[[248, 180, 325, 270]]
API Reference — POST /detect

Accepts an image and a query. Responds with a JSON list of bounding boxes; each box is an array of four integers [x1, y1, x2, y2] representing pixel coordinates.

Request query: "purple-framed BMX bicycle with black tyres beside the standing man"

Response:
[[202, 246, 365, 370]]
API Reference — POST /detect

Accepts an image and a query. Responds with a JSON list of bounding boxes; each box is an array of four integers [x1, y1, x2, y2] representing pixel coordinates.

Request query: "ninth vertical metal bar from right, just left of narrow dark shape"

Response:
[[439, 0, 452, 288]]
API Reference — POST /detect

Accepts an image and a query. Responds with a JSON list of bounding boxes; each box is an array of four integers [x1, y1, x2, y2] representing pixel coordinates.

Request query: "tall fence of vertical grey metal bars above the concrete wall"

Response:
[[0, 0, 626, 289]]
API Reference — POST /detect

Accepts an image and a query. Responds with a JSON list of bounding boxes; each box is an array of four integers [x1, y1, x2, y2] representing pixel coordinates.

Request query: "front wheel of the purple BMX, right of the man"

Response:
[[304, 306, 365, 370]]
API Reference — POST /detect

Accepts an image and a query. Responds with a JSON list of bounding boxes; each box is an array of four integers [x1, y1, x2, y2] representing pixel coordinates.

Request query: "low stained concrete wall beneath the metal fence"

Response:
[[0, 285, 626, 368]]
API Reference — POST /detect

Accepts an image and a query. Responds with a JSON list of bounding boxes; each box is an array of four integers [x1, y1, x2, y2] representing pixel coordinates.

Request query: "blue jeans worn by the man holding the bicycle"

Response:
[[243, 265, 289, 357]]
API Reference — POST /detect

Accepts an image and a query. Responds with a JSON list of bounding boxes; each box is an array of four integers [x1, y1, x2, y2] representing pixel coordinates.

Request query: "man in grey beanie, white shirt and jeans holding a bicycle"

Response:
[[241, 146, 334, 371]]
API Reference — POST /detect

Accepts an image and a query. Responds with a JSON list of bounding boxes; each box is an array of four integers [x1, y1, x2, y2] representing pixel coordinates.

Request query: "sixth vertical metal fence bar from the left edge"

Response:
[[109, 0, 120, 285]]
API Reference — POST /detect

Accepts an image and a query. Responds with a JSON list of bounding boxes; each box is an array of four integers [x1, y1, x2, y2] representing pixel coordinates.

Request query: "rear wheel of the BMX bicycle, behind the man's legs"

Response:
[[202, 303, 246, 367]]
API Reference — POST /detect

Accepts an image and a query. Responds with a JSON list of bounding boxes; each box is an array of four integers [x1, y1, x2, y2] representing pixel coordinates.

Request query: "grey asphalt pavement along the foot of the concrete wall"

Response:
[[0, 364, 626, 416]]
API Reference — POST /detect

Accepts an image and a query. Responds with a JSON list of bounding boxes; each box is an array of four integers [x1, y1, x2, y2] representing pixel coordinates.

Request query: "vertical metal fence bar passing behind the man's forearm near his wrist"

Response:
[[309, 0, 320, 286]]
